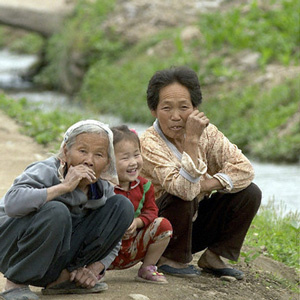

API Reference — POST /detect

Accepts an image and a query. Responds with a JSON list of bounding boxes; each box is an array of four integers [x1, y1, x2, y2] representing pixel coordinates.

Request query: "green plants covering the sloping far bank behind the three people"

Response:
[[0, 0, 300, 162]]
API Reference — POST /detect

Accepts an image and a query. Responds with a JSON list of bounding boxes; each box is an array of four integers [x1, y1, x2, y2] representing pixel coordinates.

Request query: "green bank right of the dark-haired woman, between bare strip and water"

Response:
[[202, 76, 300, 162]]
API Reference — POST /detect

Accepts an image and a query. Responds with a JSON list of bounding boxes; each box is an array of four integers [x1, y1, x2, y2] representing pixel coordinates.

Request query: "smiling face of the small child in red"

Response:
[[114, 140, 143, 189]]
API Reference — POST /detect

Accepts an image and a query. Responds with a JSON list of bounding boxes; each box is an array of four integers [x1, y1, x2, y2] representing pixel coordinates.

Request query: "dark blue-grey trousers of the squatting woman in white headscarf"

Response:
[[0, 195, 133, 286]]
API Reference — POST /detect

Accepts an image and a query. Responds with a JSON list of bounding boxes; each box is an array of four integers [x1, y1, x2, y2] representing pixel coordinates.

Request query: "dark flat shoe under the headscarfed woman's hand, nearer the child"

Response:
[[42, 281, 108, 295]]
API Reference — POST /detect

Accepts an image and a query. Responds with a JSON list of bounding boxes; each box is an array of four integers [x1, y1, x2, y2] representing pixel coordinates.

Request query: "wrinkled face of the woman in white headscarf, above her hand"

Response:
[[64, 133, 109, 184]]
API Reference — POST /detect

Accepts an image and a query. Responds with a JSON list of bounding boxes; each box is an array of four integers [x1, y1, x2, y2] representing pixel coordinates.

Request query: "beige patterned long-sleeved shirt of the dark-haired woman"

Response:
[[140, 120, 254, 201]]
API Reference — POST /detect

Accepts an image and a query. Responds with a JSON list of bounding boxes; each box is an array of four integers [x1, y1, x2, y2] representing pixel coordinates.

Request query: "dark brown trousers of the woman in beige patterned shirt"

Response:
[[157, 183, 261, 263]]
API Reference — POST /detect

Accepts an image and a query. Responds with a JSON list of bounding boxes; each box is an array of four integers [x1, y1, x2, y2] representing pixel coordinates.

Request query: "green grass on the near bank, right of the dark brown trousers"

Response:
[[242, 201, 300, 269]]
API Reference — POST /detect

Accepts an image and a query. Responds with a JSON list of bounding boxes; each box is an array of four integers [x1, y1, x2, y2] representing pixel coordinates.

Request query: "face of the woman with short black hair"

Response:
[[151, 82, 194, 141]]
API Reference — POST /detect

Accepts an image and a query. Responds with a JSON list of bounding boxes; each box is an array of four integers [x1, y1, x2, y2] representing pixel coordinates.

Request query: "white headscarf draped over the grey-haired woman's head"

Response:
[[60, 120, 119, 184]]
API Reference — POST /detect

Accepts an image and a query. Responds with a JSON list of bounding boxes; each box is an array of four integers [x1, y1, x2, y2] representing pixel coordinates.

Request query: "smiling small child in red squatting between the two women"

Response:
[[110, 125, 172, 284]]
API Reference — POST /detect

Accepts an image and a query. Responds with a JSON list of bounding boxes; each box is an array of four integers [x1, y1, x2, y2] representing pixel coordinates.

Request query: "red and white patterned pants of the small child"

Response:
[[109, 218, 172, 269]]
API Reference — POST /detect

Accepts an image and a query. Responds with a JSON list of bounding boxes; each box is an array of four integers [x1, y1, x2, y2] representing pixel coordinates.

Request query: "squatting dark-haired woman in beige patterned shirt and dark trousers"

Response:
[[141, 67, 261, 279]]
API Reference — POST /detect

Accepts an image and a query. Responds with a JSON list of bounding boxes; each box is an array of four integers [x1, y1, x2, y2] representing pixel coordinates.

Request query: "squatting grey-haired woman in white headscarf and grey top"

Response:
[[0, 120, 133, 300]]
